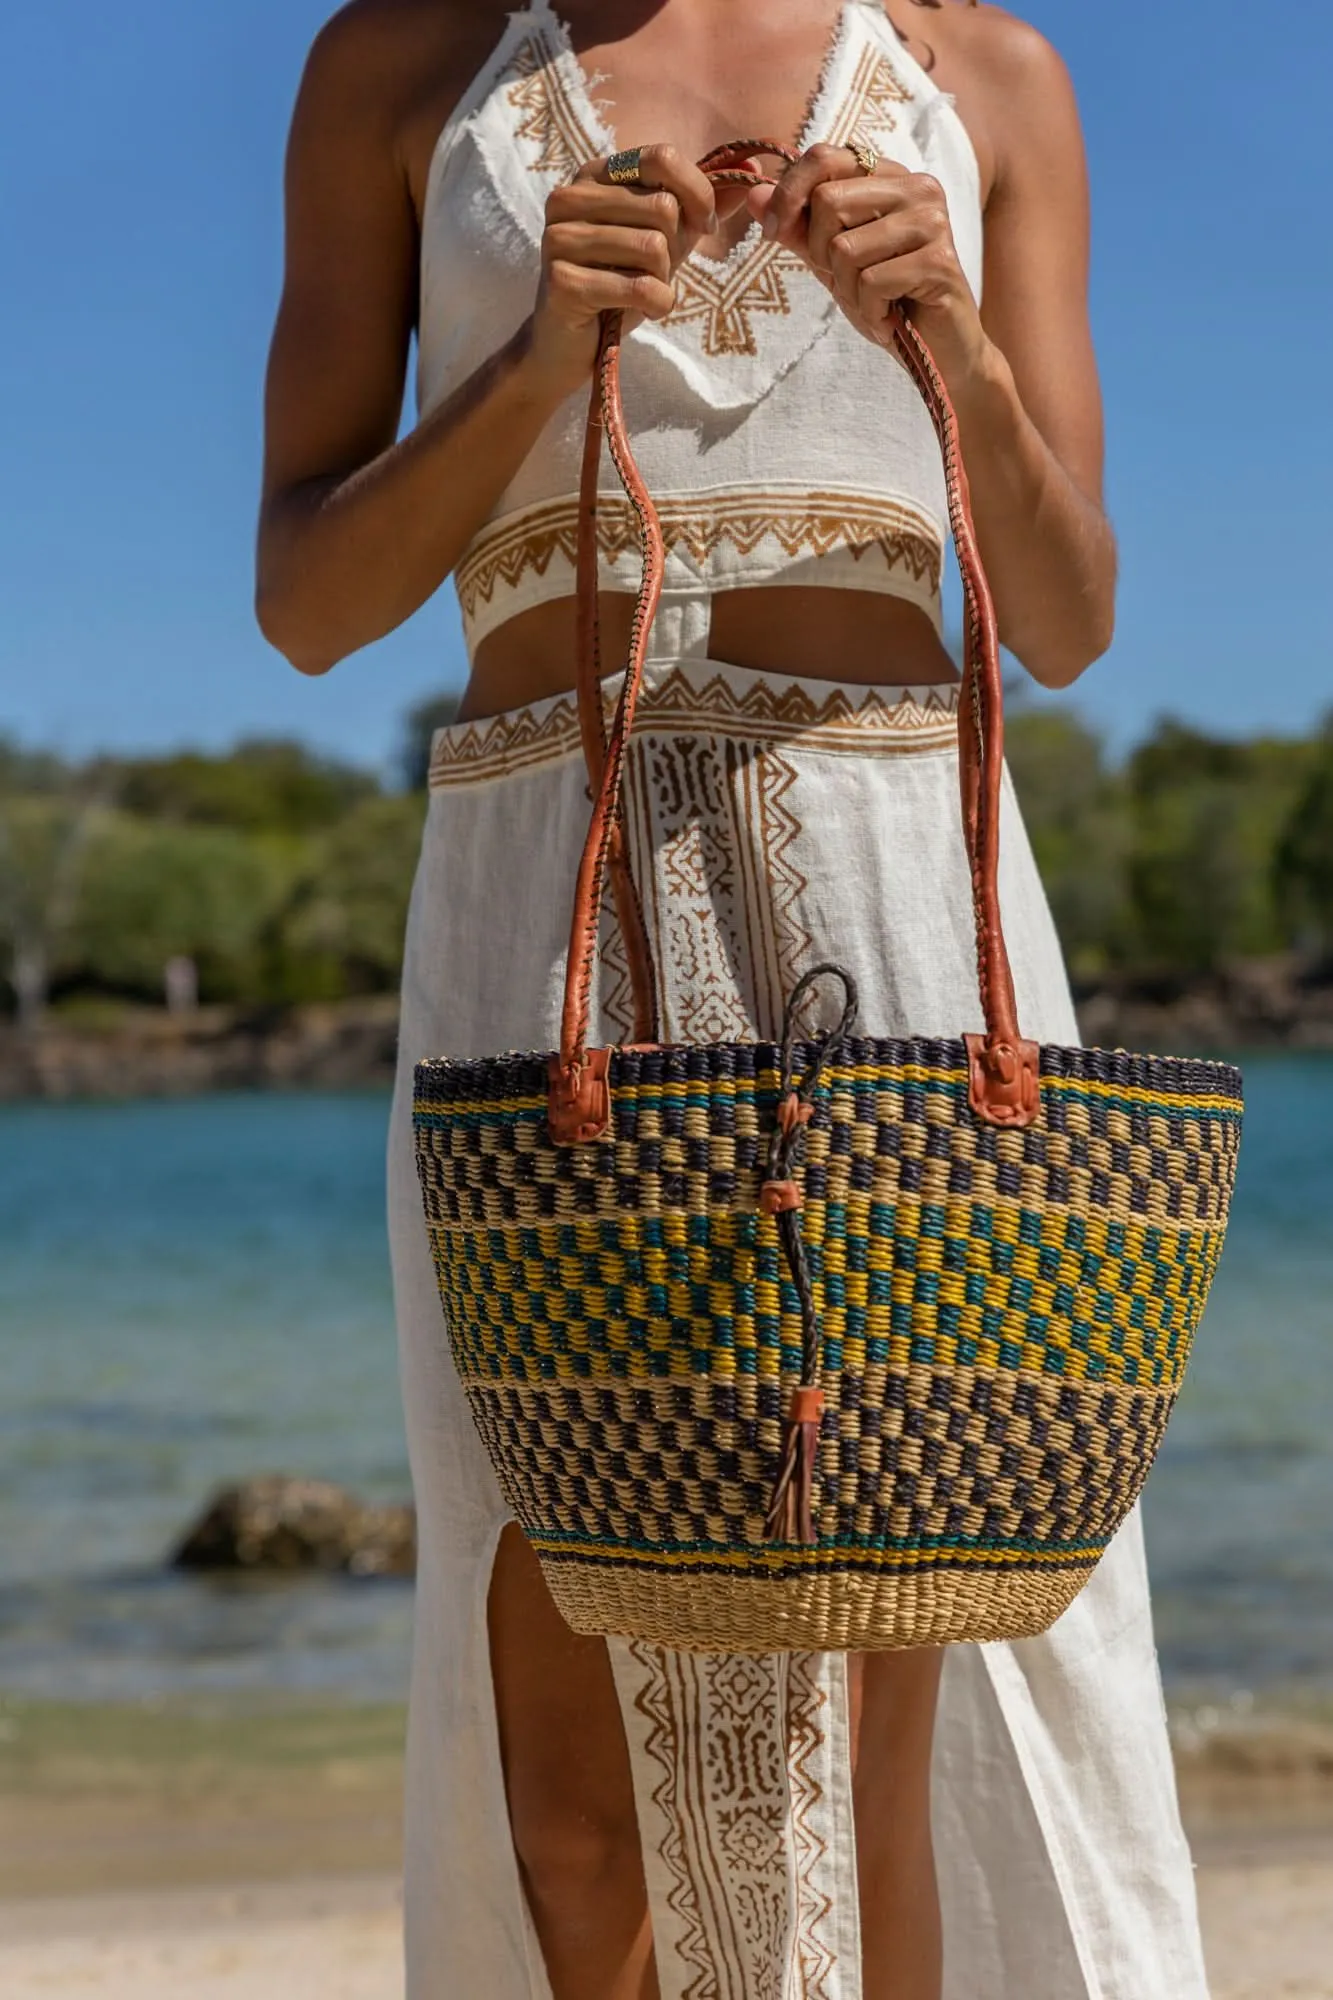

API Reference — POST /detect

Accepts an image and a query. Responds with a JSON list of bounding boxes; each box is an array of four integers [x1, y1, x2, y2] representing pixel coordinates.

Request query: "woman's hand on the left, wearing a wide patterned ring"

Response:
[[530, 146, 717, 394]]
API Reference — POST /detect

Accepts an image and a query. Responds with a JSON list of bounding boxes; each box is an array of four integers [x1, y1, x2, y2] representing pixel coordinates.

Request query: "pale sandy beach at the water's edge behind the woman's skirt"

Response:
[[0, 1704, 1333, 2000]]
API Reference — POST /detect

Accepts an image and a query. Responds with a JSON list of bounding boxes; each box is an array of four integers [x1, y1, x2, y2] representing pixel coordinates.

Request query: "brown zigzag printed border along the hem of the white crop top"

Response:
[[454, 488, 943, 618]]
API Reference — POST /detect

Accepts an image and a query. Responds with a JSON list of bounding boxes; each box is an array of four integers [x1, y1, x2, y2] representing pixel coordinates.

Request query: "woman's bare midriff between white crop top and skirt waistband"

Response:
[[458, 586, 959, 720]]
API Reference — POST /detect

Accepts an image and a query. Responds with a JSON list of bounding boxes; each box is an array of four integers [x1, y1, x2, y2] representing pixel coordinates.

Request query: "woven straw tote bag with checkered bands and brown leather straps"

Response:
[[414, 142, 1241, 1652]]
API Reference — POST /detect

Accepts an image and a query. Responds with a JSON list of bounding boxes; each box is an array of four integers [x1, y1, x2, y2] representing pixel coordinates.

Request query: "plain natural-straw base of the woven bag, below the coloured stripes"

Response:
[[540, 1558, 1095, 1652]]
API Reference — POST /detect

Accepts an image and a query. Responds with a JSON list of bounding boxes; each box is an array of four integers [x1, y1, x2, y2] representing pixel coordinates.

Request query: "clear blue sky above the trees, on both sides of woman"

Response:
[[0, 0, 1333, 762]]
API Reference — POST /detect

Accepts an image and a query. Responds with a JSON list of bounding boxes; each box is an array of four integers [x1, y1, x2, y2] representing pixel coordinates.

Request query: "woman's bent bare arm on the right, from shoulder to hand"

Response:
[[751, 10, 1115, 688]]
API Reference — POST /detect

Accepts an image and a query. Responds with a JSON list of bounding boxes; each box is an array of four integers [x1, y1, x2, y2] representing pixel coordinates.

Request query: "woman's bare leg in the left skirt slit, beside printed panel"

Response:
[[490, 1524, 658, 2000]]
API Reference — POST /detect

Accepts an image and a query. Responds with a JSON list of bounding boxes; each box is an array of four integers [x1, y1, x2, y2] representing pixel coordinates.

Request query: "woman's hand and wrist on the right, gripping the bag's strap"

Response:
[[749, 146, 989, 388]]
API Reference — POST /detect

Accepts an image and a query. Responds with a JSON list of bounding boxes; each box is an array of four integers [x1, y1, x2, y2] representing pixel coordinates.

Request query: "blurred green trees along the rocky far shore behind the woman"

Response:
[[0, 694, 1333, 1102]]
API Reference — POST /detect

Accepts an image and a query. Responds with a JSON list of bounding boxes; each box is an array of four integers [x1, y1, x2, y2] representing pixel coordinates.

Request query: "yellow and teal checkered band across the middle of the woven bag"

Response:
[[430, 1194, 1221, 1388]]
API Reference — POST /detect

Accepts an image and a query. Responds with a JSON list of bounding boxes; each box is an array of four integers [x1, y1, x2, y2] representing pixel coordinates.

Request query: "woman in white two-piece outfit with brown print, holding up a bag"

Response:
[[258, 0, 1207, 2000]]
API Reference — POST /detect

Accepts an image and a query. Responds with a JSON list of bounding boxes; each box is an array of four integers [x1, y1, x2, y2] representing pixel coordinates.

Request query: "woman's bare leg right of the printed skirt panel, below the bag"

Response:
[[849, 1648, 945, 2000]]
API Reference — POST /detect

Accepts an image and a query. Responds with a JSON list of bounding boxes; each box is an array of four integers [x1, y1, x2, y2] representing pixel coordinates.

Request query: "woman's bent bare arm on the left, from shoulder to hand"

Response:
[[256, 8, 713, 674]]
